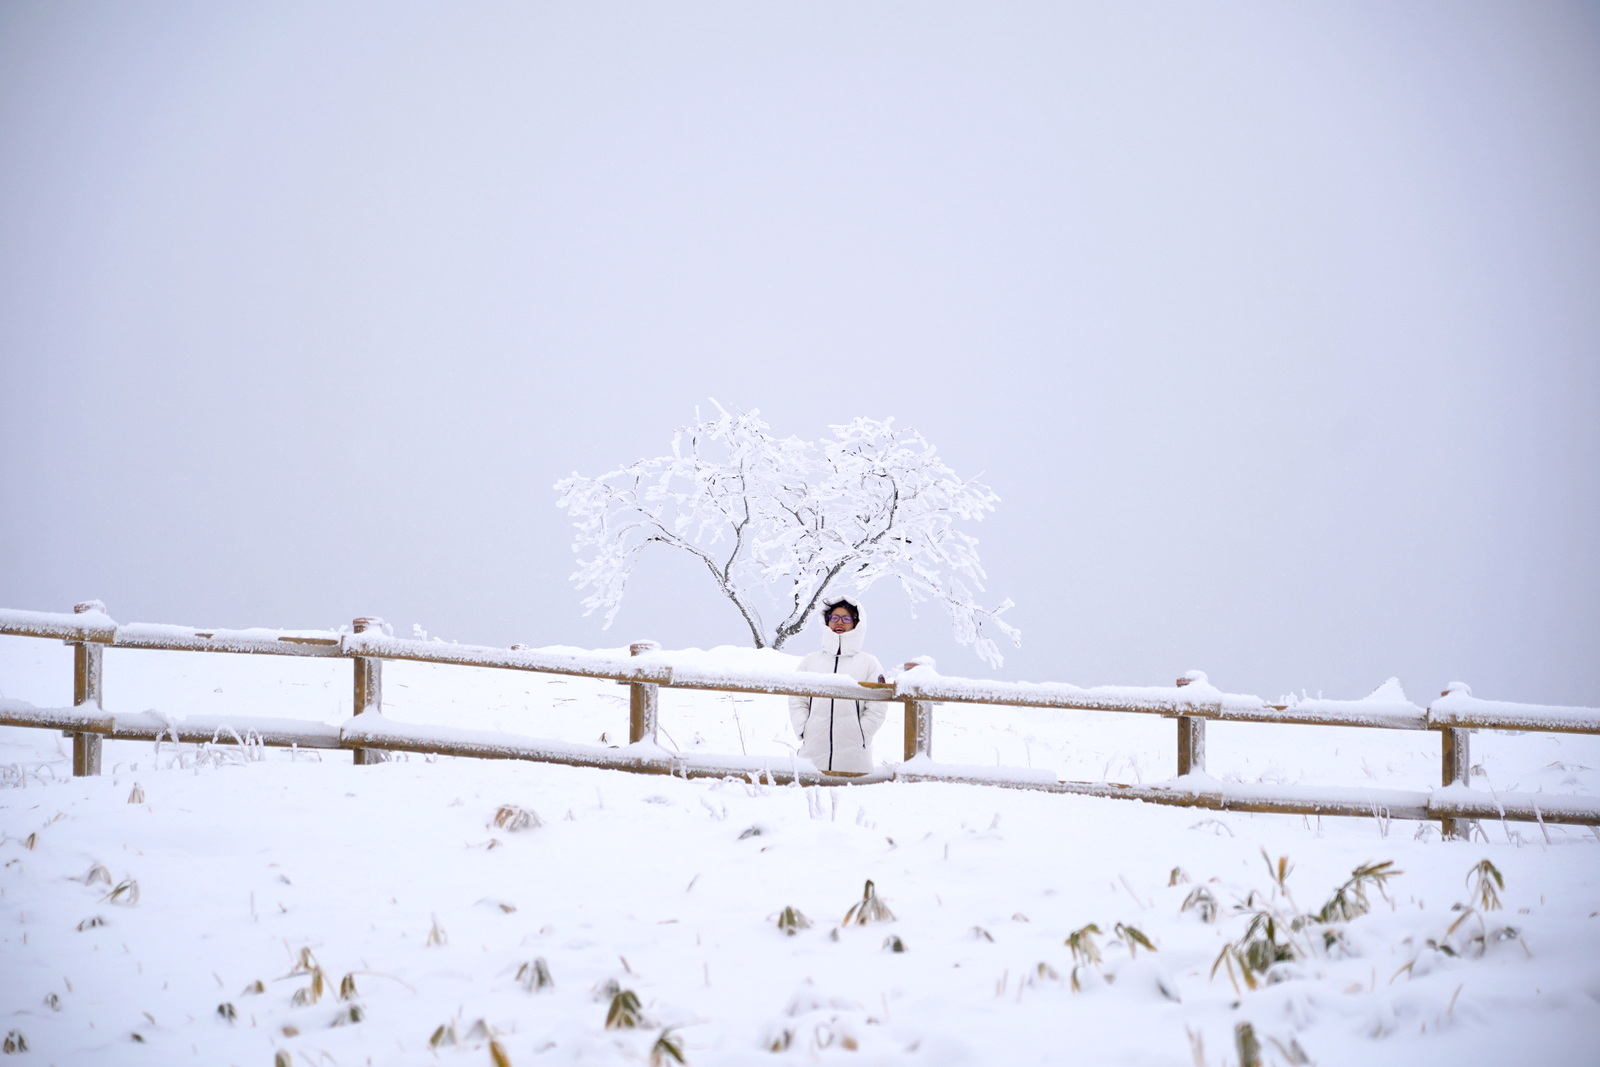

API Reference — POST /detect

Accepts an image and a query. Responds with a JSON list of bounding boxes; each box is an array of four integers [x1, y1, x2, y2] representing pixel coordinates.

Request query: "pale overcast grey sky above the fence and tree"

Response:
[[0, 0, 1600, 704]]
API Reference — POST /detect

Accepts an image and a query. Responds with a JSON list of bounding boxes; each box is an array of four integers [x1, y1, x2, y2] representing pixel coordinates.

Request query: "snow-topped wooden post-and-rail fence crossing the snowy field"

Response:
[[0, 601, 1600, 837]]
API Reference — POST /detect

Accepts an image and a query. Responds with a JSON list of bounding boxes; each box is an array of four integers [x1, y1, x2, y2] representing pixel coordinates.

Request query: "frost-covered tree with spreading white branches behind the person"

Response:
[[555, 402, 1021, 667]]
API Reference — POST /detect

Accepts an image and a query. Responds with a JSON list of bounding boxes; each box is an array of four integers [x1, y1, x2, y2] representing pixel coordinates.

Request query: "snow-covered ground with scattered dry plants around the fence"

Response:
[[0, 638, 1600, 1067]]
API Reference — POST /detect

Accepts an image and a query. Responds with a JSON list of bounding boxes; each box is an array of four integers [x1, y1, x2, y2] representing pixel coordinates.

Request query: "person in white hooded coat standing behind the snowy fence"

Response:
[[789, 598, 888, 774]]
